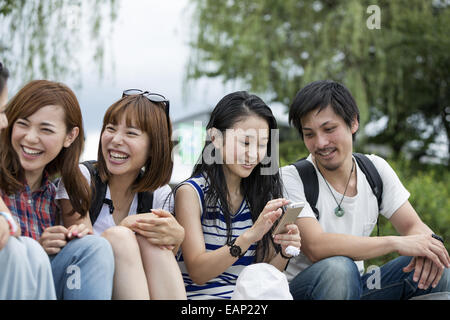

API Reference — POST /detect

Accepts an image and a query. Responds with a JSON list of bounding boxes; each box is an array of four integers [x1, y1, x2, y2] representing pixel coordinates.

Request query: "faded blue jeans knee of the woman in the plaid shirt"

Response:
[[50, 235, 114, 300]]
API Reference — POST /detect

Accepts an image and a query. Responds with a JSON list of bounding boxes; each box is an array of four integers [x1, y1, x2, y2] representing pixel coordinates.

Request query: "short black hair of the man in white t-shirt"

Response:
[[289, 80, 360, 139]]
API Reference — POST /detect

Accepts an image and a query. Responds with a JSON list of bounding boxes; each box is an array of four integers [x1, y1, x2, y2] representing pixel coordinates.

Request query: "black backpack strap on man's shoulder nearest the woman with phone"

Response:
[[293, 158, 320, 220]]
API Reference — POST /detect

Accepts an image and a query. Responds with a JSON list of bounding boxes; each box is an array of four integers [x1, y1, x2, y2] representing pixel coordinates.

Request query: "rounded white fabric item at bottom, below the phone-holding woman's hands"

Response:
[[231, 263, 293, 300]]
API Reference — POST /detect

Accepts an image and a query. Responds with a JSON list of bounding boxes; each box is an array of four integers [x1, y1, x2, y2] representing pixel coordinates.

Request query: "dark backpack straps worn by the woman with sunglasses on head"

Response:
[[81, 160, 153, 225]]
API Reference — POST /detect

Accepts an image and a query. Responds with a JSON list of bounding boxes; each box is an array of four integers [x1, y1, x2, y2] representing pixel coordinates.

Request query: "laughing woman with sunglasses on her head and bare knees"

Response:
[[58, 89, 186, 300]]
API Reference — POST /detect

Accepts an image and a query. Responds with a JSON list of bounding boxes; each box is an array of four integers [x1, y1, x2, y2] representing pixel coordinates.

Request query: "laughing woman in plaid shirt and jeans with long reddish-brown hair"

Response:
[[0, 80, 114, 300]]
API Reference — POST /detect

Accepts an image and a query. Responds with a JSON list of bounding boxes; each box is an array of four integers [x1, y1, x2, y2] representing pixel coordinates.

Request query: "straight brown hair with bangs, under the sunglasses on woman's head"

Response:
[[97, 95, 173, 192]]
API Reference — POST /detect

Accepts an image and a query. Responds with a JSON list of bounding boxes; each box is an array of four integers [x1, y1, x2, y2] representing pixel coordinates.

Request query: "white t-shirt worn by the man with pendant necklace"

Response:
[[280, 155, 410, 281]]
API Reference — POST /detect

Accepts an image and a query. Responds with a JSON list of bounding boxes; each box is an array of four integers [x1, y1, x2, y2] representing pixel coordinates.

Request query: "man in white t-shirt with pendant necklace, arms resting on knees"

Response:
[[281, 81, 450, 299]]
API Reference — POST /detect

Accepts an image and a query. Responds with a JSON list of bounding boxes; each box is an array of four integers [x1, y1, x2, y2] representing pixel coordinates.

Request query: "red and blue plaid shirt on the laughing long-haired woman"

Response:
[[0, 172, 59, 240]]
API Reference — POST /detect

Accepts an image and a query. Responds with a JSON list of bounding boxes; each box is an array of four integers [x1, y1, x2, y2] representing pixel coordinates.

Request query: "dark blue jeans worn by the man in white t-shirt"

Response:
[[289, 256, 450, 300]]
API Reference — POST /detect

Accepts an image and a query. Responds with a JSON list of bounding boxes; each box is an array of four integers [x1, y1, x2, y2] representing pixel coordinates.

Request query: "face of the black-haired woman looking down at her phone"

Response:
[[221, 115, 269, 178]]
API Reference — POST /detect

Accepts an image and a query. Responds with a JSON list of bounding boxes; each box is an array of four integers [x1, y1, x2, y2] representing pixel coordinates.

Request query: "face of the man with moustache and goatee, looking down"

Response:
[[301, 106, 359, 171]]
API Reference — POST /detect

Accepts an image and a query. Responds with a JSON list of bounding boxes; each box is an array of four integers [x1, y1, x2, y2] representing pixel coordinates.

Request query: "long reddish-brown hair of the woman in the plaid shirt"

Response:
[[0, 80, 91, 216]]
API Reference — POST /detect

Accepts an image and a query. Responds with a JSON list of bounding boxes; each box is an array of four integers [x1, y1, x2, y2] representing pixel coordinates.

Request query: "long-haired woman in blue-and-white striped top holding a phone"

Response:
[[175, 91, 300, 299]]
